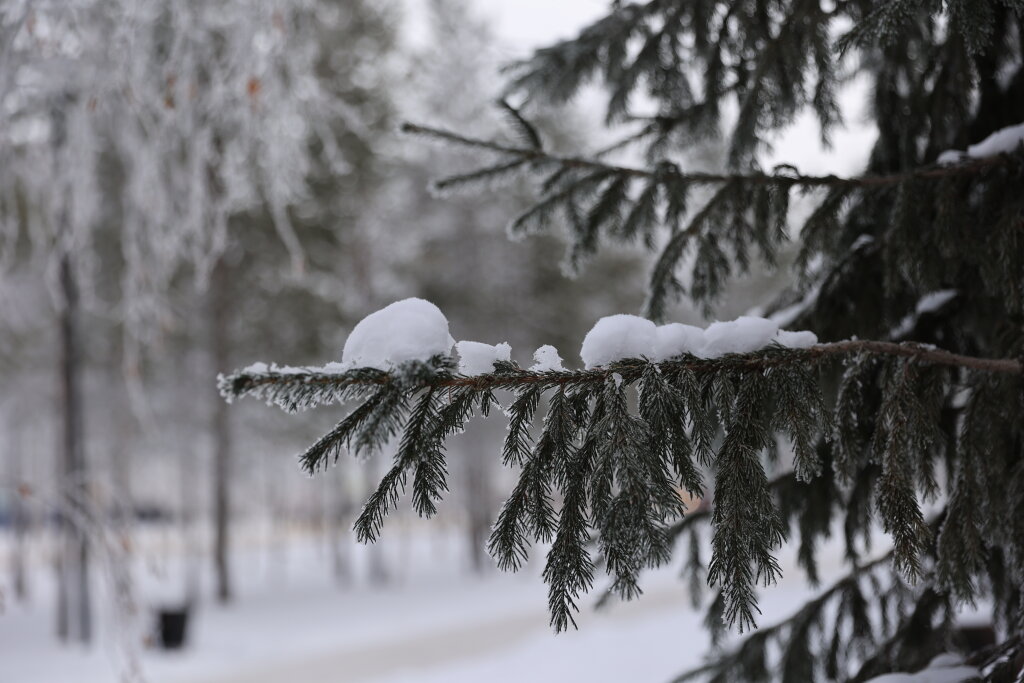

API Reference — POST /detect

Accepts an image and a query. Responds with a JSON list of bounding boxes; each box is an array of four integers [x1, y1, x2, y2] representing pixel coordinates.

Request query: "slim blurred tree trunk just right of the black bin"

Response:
[[209, 260, 233, 603]]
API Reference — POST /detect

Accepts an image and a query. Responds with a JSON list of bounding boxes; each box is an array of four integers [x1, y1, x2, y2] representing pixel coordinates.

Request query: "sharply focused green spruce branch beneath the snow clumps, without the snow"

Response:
[[220, 340, 1024, 630]]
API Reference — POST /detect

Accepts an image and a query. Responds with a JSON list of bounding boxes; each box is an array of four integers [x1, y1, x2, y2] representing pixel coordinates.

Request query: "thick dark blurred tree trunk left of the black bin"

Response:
[[57, 254, 92, 642]]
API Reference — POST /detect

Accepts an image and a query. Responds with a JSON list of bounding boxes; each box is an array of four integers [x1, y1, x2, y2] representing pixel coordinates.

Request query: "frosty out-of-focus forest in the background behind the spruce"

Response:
[[0, 0, 771, 667]]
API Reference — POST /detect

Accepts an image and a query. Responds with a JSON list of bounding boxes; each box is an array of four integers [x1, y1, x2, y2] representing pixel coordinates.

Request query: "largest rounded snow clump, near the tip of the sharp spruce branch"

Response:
[[341, 298, 455, 370]]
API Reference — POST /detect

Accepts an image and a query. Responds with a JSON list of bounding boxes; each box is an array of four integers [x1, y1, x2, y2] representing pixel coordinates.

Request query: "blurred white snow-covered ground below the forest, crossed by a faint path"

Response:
[[0, 526, 831, 683]]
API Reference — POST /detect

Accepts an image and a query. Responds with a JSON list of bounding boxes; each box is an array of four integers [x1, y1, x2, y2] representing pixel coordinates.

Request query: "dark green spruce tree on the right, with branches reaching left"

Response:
[[220, 0, 1024, 681]]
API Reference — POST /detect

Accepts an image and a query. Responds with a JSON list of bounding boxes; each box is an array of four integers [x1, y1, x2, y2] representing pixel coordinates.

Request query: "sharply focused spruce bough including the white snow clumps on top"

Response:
[[220, 299, 1022, 679]]
